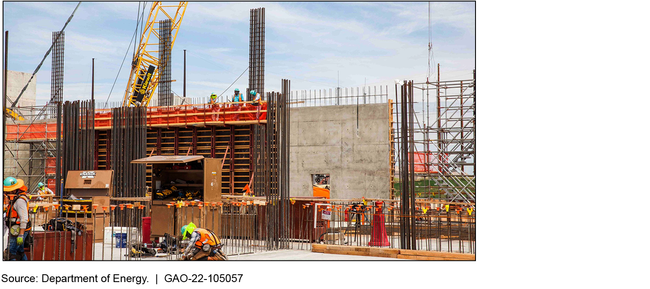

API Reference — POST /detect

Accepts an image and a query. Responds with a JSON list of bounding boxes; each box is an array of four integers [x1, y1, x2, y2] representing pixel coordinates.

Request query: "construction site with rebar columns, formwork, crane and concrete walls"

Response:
[[3, 2, 477, 261]]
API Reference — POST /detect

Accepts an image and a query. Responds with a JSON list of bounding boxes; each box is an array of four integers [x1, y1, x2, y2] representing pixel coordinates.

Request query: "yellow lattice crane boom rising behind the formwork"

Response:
[[122, 2, 187, 106]]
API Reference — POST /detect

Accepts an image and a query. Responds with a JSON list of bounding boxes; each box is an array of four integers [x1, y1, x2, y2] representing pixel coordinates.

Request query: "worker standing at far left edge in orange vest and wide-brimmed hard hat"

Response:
[[3, 177, 32, 261]]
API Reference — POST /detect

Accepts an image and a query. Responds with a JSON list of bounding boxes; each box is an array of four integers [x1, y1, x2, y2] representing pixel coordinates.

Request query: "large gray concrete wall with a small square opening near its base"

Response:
[[290, 104, 390, 199]]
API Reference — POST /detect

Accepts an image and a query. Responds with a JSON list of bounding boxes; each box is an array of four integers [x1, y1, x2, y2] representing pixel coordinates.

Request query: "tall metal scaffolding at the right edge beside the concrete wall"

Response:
[[393, 67, 476, 206]]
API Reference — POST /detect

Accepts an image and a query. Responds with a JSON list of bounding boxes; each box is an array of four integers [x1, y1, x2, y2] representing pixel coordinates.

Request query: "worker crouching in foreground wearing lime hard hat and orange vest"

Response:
[[181, 222, 228, 261]]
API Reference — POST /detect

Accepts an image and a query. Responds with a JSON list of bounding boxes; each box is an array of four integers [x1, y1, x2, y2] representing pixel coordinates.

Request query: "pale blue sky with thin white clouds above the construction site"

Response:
[[3, 2, 475, 104]]
